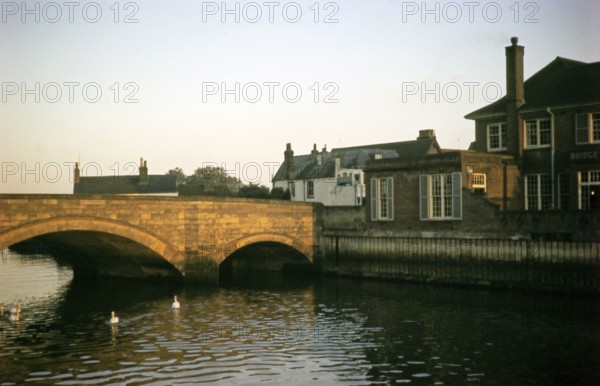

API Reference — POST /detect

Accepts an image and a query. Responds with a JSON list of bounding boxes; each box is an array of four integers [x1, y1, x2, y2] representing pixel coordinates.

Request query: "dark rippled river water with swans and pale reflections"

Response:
[[0, 250, 600, 385]]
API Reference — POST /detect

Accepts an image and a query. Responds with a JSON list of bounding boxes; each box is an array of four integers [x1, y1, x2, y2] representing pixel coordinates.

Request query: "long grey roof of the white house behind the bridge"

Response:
[[273, 137, 441, 182]]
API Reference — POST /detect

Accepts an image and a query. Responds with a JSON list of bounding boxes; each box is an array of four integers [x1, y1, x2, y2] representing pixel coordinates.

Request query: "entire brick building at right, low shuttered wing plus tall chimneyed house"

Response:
[[365, 38, 600, 240]]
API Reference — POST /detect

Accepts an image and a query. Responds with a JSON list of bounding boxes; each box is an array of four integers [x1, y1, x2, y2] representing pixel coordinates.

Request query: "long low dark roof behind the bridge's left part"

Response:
[[73, 174, 177, 194]]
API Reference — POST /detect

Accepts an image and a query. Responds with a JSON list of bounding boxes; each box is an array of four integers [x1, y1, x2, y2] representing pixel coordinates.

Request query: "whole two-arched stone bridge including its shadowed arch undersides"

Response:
[[0, 194, 318, 283]]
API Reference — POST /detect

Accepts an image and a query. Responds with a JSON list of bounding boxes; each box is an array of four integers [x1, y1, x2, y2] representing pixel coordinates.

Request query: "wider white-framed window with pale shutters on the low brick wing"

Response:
[[419, 173, 462, 220]]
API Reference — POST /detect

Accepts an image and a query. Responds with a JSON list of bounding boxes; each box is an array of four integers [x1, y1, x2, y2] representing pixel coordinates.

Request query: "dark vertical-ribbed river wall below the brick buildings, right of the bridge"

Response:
[[318, 235, 600, 294]]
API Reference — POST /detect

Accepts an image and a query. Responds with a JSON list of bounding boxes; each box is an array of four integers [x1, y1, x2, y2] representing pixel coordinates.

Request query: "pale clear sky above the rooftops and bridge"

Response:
[[0, 0, 600, 193]]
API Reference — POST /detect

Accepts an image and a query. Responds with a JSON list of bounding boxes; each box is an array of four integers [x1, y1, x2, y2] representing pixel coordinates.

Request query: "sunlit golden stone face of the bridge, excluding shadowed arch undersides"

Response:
[[0, 194, 318, 283]]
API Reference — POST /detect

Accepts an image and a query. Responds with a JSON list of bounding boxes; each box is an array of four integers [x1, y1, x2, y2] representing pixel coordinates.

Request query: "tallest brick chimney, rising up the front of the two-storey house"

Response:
[[506, 37, 525, 158]]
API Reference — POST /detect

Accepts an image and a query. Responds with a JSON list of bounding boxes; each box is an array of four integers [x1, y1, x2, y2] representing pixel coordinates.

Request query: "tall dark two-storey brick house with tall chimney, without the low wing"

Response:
[[465, 38, 600, 210]]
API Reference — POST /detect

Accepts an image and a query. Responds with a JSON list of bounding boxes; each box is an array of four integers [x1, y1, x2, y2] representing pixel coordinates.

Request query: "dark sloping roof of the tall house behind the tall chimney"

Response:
[[465, 56, 600, 119]]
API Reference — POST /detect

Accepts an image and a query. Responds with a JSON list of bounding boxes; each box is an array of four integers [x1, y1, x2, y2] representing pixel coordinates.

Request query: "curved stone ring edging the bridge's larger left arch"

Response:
[[0, 217, 185, 272]]
